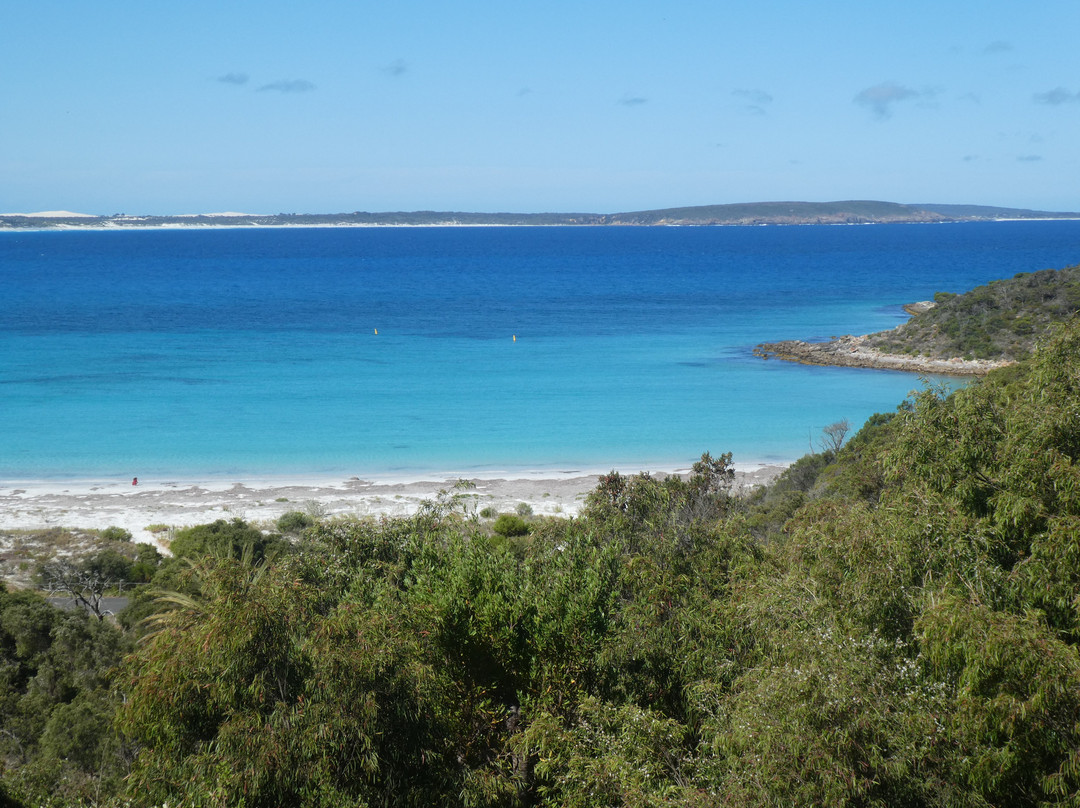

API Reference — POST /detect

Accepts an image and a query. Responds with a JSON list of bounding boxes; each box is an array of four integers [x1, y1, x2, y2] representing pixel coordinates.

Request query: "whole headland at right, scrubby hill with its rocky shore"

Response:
[[754, 265, 1080, 376]]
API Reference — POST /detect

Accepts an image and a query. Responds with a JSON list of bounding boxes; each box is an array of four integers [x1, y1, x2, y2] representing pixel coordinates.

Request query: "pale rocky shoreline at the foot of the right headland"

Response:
[[754, 335, 1015, 376]]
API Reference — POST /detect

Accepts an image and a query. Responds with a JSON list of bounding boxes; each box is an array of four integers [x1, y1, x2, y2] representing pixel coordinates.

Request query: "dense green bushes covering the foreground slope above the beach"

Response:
[[6, 320, 1080, 808]]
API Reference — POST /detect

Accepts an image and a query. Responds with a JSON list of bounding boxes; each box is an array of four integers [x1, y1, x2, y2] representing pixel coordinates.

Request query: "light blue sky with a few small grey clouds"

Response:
[[0, 0, 1080, 215]]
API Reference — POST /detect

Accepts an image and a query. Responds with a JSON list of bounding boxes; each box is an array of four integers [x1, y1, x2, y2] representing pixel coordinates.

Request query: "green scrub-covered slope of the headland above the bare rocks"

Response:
[[867, 266, 1080, 360]]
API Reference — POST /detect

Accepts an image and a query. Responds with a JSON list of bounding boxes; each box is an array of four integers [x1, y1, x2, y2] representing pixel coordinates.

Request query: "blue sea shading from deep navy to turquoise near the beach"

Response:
[[0, 221, 1080, 480]]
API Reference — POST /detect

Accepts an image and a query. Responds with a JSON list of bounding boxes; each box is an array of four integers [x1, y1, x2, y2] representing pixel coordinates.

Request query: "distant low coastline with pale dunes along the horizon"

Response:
[[0, 200, 1080, 230]]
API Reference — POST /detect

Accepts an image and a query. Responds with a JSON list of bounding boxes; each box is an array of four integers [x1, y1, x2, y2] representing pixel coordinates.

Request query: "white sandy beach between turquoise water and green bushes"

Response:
[[0, 464, 785, 543]]
